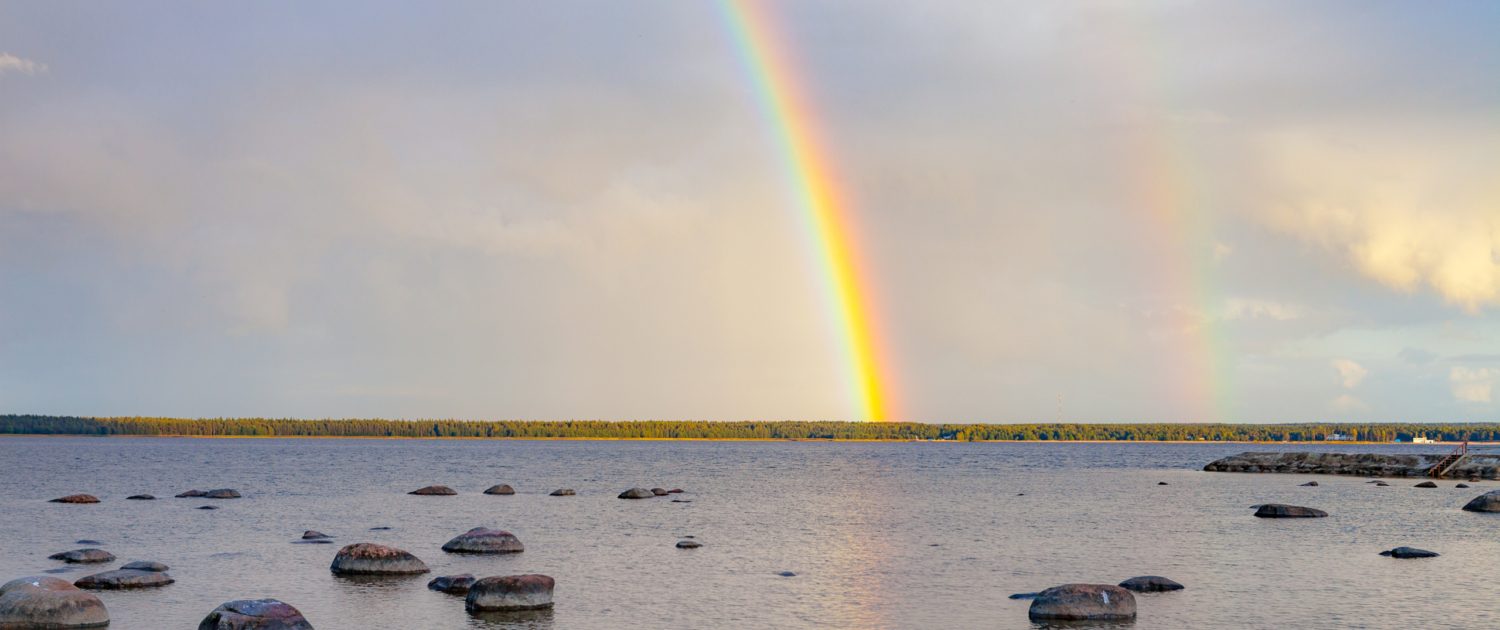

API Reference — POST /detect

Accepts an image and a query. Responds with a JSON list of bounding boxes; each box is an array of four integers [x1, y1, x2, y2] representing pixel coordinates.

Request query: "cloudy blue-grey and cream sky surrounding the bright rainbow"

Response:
[[0, 0, 1500, 422]]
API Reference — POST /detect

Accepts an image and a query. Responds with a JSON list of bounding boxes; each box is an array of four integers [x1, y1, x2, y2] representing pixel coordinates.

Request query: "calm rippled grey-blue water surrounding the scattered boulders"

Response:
[[0, 438, 1500, 630]]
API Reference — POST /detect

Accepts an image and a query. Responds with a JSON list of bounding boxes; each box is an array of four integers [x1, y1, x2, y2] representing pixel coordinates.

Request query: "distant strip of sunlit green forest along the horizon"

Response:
[[0, 416, 1500, 443]]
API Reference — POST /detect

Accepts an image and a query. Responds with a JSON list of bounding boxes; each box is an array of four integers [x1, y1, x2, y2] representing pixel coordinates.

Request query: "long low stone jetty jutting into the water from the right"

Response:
[[1203, 452, 1500, 479]]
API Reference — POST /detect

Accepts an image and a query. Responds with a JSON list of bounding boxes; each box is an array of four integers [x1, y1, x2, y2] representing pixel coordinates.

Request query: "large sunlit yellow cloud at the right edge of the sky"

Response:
[[1265, 128, 1500, 314]]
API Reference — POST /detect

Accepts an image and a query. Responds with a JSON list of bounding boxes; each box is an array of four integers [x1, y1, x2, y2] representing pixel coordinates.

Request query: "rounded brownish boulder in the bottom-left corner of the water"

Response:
[[0, 576, 110, 630]]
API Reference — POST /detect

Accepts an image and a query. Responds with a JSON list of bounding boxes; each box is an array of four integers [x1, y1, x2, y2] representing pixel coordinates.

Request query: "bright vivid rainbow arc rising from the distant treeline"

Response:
[[720, 0, 891, 422]]
